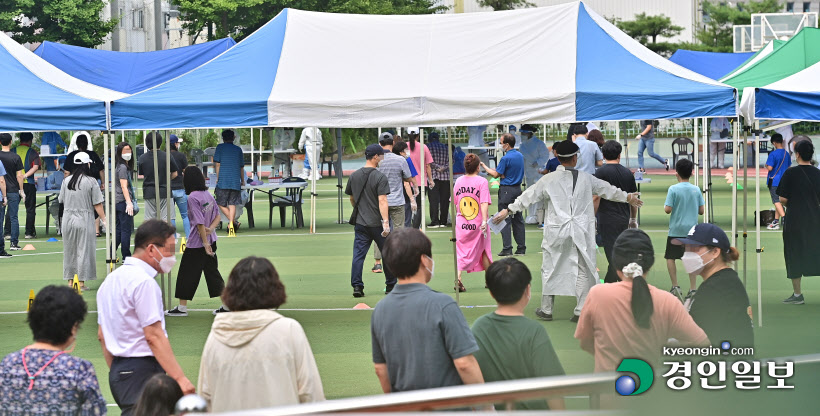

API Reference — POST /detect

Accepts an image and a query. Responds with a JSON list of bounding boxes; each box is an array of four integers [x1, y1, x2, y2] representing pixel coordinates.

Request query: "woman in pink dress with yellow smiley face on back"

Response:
[[453, 153, 493, 292]]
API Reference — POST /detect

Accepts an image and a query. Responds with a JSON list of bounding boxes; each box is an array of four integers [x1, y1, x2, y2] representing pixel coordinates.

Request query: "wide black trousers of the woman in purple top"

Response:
[[174, 243, 225, 300]]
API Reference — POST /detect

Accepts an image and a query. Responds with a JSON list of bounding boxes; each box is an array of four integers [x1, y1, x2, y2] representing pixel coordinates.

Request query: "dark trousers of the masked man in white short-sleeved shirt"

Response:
[[108, 357, 165, 416]]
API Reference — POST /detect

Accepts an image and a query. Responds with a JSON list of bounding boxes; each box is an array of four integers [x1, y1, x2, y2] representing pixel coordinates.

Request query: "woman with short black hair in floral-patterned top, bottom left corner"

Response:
[[0, 286, 106, 415]]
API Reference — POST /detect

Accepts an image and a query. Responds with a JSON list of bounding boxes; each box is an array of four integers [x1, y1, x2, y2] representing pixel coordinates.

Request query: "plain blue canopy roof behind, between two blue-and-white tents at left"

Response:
[[34, 38, 236, 94]]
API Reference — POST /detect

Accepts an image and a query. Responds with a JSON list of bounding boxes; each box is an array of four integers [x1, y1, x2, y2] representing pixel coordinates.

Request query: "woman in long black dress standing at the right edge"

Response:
[[777, 138, 820, 305]]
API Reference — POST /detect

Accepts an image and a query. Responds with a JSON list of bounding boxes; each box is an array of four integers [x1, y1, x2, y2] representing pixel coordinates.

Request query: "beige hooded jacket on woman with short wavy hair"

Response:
[[197, 310, 325, 412]]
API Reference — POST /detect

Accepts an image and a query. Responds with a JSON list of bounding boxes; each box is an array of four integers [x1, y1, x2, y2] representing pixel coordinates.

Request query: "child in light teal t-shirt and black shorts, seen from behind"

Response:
[[663, 159, 704, 301]]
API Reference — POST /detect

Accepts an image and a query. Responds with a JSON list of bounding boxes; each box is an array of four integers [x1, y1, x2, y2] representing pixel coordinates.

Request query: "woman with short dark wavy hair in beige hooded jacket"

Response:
[[197, 257, 325, 413]]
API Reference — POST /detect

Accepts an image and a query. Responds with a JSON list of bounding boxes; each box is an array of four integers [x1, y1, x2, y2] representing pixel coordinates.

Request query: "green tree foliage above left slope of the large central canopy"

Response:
[[172, 0, 447, 40]]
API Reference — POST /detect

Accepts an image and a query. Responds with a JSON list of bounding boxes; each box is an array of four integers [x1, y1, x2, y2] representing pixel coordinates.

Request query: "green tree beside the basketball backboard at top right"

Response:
[[695, 0, 782, 52]]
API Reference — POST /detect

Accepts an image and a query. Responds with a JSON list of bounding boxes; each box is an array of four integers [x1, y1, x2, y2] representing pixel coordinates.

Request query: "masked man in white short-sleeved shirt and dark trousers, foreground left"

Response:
[[97, 219, 194, 416]]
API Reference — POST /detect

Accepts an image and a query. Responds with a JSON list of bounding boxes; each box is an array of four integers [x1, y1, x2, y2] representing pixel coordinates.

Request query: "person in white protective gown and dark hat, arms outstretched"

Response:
[[493, 141, 643, 322]]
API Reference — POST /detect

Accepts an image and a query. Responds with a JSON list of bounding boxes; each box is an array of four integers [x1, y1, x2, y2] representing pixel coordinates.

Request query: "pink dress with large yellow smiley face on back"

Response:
[[453, 176, 493, 273]]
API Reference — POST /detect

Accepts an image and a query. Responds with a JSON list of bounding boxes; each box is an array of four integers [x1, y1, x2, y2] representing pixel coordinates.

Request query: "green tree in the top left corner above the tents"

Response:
[[0, 0, 117, 47]]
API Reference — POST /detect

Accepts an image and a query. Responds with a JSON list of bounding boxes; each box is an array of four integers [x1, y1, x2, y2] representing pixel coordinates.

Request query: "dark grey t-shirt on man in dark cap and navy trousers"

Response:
[[345, 167, 390, 228]]
